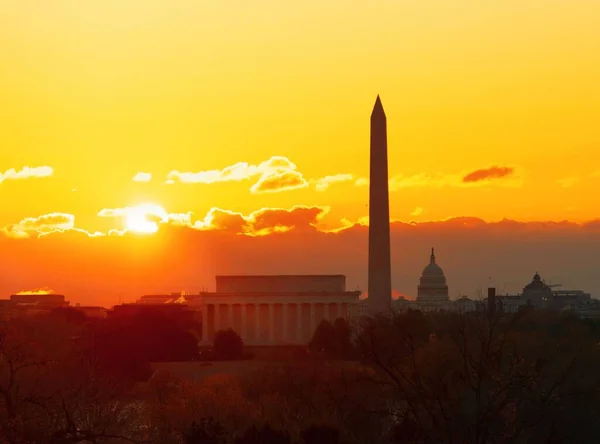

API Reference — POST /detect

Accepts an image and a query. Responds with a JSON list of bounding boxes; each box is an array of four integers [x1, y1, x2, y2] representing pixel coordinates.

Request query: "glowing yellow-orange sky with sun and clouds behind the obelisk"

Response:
[[0, 0, 600, 301]]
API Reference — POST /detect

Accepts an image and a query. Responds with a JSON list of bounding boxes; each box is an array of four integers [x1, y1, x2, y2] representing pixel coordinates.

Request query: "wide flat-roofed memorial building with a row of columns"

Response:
[[186, 275, 360, 345]]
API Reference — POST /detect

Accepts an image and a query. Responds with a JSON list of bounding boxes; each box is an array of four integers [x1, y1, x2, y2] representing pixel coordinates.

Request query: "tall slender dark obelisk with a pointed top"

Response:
[[368, 96, 392, 316]]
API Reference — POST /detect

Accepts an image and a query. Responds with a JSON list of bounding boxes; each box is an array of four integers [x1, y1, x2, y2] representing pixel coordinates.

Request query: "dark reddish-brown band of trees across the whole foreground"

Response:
[[0, 309, 600, 444]]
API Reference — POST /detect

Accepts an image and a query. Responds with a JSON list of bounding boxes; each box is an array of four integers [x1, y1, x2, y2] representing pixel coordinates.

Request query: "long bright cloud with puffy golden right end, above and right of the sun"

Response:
[[167, 156, 308, 193]]
